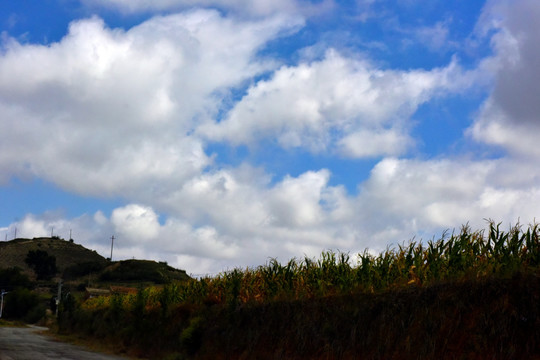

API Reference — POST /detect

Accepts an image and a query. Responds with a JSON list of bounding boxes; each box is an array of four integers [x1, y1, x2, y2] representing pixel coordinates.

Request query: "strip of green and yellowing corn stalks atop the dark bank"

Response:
[[81, 222, 540, 312]]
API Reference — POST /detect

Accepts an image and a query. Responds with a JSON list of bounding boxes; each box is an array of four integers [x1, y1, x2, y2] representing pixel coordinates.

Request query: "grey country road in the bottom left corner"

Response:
[[0, 327, 126, 360]]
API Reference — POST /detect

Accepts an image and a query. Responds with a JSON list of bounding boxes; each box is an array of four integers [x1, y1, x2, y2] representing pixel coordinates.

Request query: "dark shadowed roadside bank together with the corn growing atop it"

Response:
[[58, 222, 540, 359]]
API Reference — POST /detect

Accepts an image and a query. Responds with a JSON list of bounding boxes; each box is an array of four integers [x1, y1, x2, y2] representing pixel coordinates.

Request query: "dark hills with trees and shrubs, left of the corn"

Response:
[[0, 237, 189, 325]]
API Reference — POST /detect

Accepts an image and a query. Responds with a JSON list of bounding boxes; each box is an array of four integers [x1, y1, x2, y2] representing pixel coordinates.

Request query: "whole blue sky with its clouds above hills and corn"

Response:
[[0, 0, 540, 274]]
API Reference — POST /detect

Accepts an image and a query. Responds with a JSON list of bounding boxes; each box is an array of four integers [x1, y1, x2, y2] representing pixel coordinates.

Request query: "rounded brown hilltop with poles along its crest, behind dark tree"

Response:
[[0, 237, 108, 275]]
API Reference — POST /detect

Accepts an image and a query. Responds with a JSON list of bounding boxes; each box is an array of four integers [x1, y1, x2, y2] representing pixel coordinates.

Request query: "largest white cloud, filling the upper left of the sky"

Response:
[[0, 10, 301, 191]]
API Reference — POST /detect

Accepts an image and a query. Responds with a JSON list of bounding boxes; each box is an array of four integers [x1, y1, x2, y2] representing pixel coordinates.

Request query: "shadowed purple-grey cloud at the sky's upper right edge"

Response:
[[469, 0, 540, 158]]
